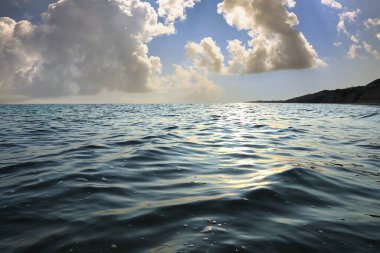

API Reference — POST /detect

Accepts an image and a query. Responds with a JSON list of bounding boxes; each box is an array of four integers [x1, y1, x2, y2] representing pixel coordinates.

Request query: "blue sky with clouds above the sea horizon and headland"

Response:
[[0, 0, 380, 103]]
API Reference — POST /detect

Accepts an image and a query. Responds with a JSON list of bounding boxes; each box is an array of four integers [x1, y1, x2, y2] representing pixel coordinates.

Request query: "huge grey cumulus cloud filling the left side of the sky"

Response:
[[0, 0, 178, 101]]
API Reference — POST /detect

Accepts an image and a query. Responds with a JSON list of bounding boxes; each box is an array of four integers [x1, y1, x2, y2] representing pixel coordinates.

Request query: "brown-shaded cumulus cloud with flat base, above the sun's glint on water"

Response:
[[187, 0, 324, 74]]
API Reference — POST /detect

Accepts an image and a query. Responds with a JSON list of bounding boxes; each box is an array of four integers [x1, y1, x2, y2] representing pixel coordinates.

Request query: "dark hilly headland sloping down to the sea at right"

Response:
[[250, 79, 380, 104]]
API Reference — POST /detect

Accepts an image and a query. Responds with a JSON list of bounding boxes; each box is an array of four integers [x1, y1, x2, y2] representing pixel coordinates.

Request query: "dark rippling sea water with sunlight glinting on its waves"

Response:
[[0, 104, 380, 253]]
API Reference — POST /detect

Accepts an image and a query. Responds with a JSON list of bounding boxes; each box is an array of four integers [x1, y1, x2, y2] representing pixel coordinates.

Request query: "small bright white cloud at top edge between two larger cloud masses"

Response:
[[157, 0, 200, 24]]
